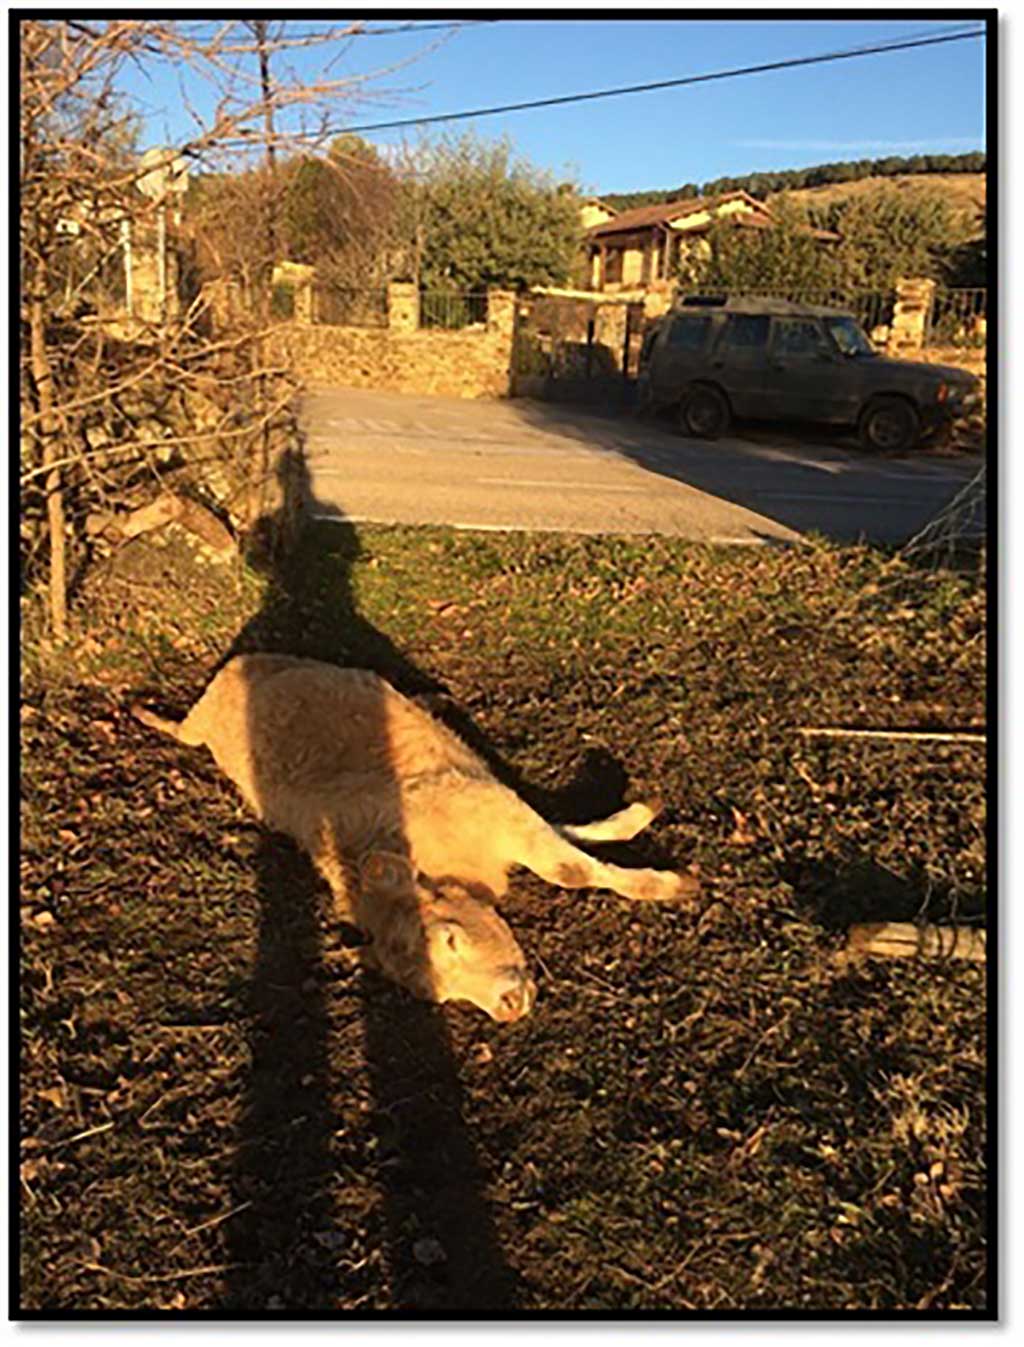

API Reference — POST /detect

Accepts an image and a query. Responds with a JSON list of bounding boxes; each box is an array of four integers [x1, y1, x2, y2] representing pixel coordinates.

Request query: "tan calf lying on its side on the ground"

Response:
[[136, 655, 695, 1018]]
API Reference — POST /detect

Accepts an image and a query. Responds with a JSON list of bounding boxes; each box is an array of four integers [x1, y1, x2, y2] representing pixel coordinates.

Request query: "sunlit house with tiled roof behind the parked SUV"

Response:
[[586, 191, 839, 292]]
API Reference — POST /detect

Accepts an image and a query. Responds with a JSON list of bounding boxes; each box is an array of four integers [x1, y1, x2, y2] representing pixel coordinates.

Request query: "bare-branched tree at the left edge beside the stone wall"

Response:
[[18, 16, 431, 640]]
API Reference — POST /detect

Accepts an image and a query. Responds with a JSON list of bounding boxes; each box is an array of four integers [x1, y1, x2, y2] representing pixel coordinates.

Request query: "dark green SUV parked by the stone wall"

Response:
[[639, 296, 980, 453]]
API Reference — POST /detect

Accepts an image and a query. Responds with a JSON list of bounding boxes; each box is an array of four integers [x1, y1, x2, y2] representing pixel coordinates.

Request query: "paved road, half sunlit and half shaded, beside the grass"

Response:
[[303, 388, 978, 543]]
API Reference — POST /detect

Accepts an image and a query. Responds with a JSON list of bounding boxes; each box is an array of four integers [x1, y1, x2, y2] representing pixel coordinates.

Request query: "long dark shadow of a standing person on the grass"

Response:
[[221, 447, 517, 1315]]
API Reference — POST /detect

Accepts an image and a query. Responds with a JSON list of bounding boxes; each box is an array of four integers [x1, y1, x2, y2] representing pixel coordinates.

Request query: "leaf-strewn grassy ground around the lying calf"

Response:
[[22, 527, 986, 1312]]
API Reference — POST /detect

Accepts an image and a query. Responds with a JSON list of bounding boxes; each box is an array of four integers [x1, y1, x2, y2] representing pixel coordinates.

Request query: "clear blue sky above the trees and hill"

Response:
[[115, 11, 985, 191]]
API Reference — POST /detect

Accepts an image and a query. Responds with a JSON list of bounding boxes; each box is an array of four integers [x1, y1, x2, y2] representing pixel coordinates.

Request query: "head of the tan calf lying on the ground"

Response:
[[360, 851, 536, 1021]]
